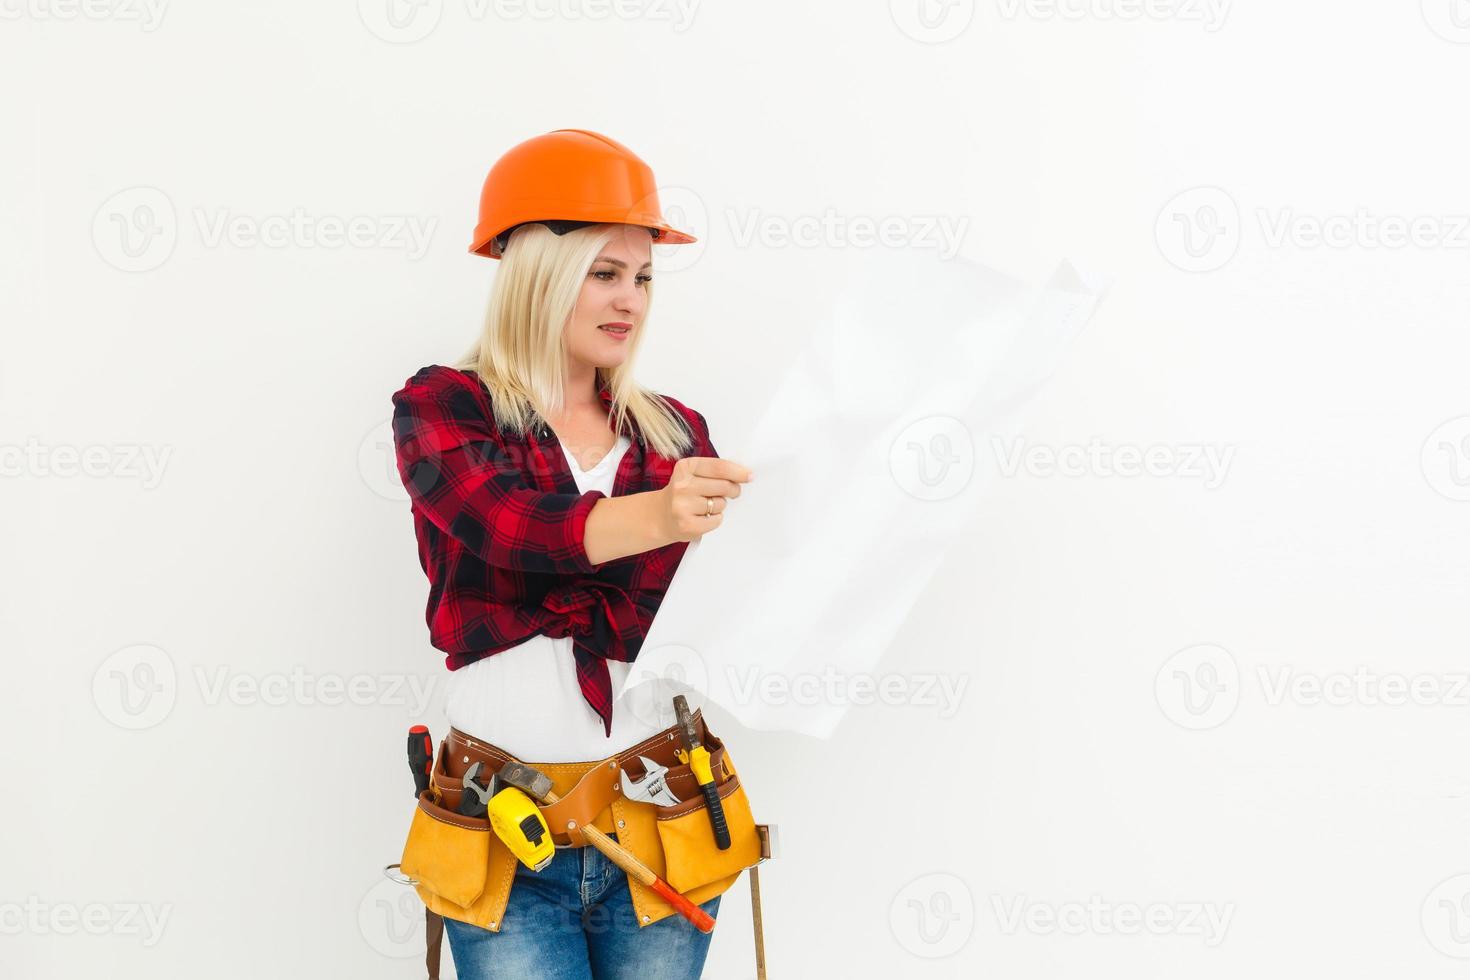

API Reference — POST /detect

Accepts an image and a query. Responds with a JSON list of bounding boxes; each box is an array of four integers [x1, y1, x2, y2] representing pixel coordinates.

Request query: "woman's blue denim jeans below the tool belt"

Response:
[[444, 846, 720, 980]]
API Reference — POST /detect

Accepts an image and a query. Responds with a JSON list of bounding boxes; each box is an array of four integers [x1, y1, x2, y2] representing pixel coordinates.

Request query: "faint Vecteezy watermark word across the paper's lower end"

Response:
[[726, 664, 970, 720]]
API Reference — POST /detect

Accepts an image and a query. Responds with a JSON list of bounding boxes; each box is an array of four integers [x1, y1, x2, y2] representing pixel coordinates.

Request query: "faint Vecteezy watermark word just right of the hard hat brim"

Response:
[[725, 207, 970, 260]]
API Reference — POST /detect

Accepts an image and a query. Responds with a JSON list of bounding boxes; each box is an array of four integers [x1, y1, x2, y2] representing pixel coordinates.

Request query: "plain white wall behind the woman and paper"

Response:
[[0, 0, 1470, 979]]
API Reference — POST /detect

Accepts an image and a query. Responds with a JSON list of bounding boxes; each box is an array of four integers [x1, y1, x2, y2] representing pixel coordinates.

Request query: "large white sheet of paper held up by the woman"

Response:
[[619, 253, 1101, 738]]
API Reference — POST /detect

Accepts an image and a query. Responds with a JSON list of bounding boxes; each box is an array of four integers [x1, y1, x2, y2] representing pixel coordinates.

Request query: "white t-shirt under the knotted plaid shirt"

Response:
[[445, 435, 664, 763]]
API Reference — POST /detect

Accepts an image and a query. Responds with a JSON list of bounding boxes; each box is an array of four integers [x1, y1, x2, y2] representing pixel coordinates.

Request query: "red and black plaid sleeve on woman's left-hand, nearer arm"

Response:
[[392, 366, 606, 574]]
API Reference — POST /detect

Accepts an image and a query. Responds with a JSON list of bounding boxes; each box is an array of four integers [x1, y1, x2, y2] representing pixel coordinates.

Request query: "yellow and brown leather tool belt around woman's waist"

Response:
[[401, 711, 761, 932]]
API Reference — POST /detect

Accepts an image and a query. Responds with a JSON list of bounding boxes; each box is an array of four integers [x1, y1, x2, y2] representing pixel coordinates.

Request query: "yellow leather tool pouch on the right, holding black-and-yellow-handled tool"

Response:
[[640, 730, 760, 893]]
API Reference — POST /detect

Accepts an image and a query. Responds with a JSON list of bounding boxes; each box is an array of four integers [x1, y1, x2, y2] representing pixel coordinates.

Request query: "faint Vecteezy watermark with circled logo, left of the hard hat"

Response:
[[93, 187, 438, 272]]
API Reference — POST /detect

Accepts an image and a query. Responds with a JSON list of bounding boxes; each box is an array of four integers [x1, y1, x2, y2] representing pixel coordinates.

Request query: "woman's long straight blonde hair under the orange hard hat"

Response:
[[454, 223, 694, 458]]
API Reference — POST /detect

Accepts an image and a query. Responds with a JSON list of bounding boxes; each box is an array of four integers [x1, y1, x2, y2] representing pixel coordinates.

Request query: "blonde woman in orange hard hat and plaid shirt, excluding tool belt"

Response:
[[392, 129, 751, 980]]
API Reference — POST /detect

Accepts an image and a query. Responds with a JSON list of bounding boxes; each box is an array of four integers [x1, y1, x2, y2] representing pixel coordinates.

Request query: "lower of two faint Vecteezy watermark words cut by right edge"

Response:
[[1255, 664, 1470, 708]]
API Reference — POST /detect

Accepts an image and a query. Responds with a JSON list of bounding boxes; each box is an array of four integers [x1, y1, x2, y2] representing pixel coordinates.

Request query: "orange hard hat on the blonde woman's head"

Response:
[[469, 129, 695, 259]]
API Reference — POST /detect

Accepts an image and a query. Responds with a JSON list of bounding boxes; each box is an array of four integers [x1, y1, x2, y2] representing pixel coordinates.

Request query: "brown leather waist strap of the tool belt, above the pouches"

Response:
[[434, 710, 731, 848]]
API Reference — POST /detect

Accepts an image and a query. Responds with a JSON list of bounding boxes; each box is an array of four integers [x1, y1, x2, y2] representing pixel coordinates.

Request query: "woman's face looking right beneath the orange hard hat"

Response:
[[566, 225, 653, 369]]
